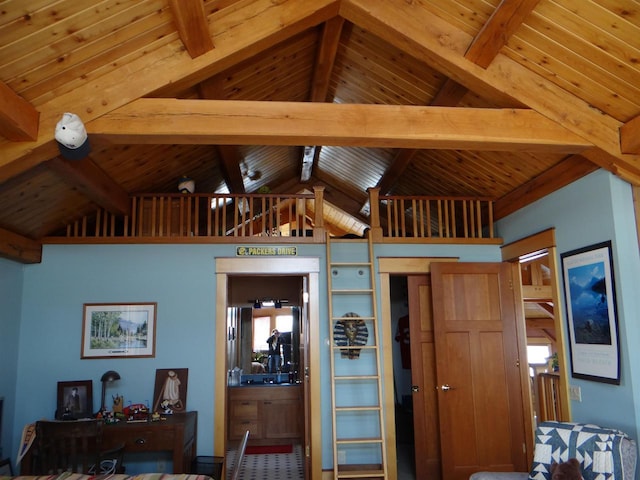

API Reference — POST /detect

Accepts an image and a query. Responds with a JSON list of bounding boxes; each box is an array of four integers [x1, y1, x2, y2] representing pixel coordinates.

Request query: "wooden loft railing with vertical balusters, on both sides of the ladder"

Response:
[[46, 187, 499, 243]]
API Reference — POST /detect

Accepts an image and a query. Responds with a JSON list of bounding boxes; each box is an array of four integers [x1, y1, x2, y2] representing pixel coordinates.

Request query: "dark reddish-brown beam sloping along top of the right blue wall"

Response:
[[493, 155, 598, 220]]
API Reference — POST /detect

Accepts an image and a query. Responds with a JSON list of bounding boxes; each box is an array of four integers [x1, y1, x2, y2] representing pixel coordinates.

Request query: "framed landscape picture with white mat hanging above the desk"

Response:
[[81, 303, 157, 358]]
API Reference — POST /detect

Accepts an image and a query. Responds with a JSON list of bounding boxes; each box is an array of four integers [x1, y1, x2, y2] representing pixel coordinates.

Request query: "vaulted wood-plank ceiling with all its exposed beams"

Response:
[[0, 0, 640, 262]]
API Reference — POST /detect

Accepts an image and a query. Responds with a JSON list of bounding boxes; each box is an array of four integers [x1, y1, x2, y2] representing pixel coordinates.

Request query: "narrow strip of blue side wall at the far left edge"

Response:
[[0, 258, 23, 458]]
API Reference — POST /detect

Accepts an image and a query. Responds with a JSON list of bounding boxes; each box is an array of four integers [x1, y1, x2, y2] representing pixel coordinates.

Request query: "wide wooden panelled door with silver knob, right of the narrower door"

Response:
[[431, 262, 527, 480]]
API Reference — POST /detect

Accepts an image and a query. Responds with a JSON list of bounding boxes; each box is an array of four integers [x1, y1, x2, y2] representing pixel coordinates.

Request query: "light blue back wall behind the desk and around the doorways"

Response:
[[9, 238, 499, 473]]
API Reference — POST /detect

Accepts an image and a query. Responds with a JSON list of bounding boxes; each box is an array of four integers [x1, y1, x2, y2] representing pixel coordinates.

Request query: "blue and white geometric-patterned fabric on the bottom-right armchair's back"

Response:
[[529, 422, 626, 480]]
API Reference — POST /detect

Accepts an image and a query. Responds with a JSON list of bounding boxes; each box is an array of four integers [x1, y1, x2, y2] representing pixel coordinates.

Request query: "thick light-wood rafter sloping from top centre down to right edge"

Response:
[[340, 0, 640, 182]]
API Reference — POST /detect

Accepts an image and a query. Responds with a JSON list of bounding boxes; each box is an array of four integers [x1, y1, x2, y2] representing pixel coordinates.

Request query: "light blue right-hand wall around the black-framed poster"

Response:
[[497, 170, 640, 446]]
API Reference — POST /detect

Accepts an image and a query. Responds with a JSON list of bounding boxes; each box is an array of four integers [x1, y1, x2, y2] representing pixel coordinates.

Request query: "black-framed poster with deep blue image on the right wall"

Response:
[[561, 241, 620, 385]]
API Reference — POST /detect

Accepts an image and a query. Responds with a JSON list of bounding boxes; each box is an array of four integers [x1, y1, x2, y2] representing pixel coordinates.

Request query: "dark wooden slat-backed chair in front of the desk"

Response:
[[34, 420, 124, 475]]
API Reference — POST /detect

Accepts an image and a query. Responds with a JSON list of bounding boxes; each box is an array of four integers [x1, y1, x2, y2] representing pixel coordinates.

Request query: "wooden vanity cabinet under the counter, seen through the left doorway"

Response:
[[227, 385, 303, 445]]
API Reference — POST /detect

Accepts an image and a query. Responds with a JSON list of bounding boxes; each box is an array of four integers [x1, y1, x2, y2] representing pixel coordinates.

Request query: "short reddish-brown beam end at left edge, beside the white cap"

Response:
[[0, 82, 40, 142]]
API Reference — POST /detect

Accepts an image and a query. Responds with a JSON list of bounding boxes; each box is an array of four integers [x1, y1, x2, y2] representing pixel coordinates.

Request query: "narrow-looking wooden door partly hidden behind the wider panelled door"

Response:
[[407, 275, 442, 480]]
